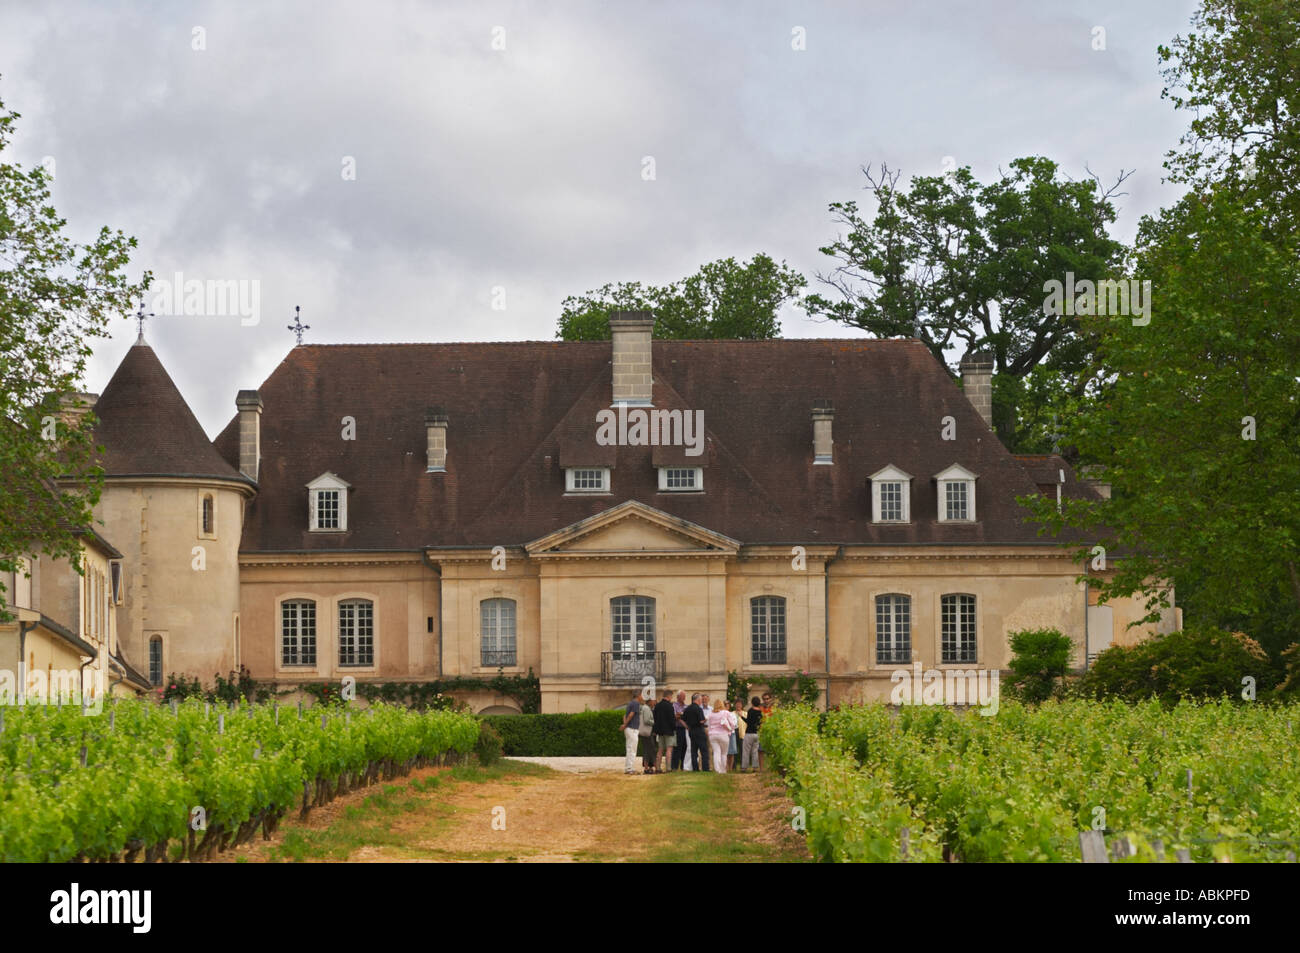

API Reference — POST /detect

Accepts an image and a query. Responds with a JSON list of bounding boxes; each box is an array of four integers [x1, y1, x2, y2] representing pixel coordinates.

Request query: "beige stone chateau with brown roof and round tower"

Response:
[[15, 312, 1178, 711]]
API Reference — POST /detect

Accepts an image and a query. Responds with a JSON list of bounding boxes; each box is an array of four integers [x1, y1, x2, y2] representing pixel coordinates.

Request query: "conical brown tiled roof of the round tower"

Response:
[[94, 343, 251, 484]]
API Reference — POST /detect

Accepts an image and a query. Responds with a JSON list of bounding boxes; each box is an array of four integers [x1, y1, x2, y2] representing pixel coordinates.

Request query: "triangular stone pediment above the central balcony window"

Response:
[[524, 499, 740, 556]]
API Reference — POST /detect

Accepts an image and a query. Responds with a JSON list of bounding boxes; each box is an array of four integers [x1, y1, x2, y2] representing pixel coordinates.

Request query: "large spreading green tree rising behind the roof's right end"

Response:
[[803, 156, 1127, 450]]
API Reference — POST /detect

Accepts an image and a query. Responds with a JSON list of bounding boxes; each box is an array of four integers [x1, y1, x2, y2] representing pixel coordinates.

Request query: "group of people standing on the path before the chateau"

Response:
[[623, 689, 772, 775]]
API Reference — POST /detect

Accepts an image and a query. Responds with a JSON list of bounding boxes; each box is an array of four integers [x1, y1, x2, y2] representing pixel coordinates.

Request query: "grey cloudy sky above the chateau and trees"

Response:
[[0, 0, 1196, 436]]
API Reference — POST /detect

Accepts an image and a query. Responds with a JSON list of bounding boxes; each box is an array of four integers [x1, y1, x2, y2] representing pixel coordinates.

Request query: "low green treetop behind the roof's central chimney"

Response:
[[555, 254, 807, 341]]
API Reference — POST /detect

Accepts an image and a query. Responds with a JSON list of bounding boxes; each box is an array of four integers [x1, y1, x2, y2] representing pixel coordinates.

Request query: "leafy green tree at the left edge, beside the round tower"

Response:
[[0, 96, 147, 612]]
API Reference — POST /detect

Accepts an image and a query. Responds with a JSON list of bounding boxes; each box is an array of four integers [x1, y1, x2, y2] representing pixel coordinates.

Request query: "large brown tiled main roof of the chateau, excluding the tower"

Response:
[[216, 339, 1086, 551]]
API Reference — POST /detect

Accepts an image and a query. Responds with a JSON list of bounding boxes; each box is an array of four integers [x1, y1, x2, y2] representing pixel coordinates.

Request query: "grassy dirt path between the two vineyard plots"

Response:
[[222, 759, 807, 862]]
